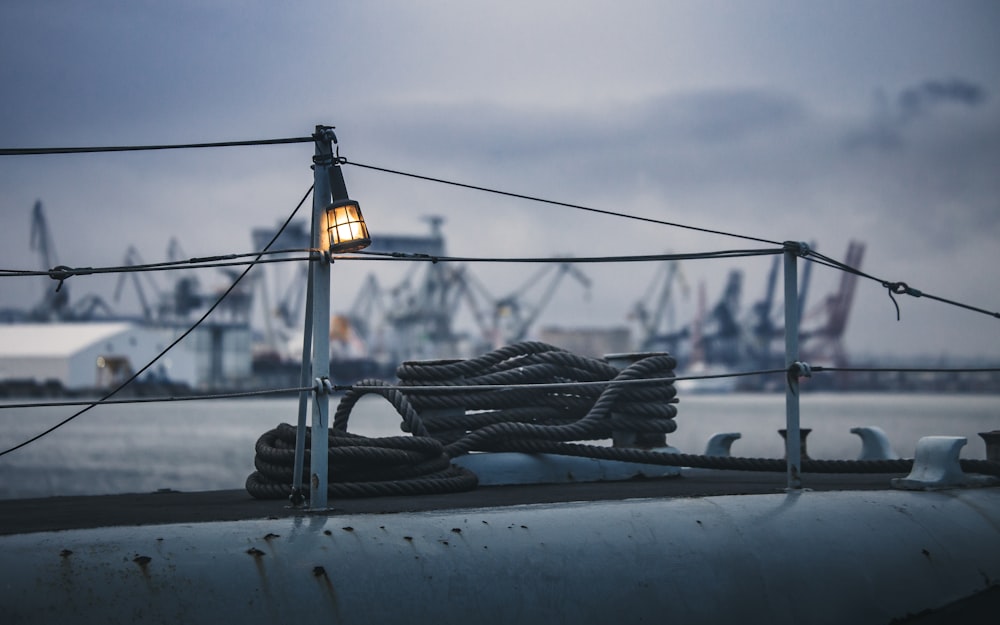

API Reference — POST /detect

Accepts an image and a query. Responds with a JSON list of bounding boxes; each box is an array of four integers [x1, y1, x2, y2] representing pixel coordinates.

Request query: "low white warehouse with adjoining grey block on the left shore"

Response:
[[0, 322, 251, 389]]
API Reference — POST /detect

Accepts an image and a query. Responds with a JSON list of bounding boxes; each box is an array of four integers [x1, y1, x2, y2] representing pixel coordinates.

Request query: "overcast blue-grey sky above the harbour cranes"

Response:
[[0, 0, 1000, 361]]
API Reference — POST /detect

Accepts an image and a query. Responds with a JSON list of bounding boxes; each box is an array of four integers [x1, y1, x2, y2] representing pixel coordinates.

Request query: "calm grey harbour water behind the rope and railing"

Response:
[[0, 393, 1000, 499]]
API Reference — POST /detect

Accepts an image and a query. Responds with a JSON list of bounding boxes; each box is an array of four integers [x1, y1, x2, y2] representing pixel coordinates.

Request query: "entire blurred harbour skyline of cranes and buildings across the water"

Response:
[[0, 202, 997, 394]]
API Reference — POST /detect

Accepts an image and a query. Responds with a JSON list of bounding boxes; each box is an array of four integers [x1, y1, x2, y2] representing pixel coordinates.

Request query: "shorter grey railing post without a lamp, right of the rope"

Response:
[[784, 243, 802, 490]]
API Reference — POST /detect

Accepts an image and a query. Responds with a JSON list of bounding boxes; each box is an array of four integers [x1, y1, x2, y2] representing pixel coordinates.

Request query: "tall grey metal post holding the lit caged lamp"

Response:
[[309, 126, 333, 510]]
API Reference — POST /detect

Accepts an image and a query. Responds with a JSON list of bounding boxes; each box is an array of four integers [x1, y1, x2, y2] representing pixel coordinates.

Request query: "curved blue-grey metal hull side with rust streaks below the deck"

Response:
[[0, 489, 1000, 625]]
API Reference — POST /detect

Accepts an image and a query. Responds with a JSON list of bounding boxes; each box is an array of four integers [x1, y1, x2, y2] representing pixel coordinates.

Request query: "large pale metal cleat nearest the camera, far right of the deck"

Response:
[[892, 436, 1000, 490]]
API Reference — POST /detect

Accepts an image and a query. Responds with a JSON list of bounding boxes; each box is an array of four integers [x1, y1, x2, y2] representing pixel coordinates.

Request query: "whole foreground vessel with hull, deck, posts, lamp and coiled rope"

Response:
[[0, 127, 1000, 625]]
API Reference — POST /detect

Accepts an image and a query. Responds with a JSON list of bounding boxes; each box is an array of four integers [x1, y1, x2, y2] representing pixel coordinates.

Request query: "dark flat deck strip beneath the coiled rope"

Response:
[[0, 470, 899, 535]]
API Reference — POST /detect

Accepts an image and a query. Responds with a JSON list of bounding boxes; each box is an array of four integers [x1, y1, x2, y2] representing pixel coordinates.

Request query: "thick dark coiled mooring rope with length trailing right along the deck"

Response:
[[246, 341, 1000, 499]]
